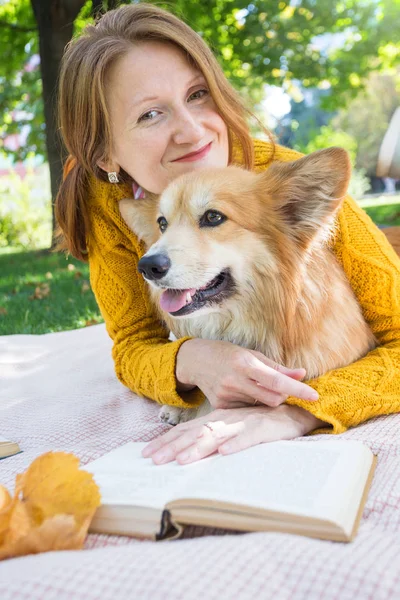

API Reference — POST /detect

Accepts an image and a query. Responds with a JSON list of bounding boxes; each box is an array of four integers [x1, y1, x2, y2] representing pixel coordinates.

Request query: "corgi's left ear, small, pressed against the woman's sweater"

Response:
[[118, 196, 160, 248]]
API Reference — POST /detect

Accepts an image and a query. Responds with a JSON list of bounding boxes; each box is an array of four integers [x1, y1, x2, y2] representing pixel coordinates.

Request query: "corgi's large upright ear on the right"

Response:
[[262, 148, 351, 242]]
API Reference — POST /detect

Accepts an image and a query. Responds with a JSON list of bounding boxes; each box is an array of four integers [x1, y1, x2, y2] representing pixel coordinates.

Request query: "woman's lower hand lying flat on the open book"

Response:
[[142, 404, 327, 465]]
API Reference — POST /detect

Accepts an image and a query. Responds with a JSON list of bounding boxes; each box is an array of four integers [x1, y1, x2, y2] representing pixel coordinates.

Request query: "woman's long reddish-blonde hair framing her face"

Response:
[[55, 3, 270, 260]]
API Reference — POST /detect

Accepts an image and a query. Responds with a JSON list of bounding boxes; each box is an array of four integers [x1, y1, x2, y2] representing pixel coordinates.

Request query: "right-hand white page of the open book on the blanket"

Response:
[[168, 441, 373, 521]]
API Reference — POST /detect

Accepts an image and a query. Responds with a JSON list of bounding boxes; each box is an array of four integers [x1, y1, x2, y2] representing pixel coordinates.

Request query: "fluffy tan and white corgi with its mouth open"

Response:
[[120, 148, 377, 423]]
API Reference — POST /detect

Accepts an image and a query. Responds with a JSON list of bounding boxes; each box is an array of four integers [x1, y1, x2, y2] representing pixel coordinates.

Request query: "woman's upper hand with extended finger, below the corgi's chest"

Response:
[[176, 338, 318, 408]]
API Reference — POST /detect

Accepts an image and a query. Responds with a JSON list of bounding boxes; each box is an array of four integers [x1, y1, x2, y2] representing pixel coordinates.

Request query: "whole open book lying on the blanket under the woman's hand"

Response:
[[85, 440, 376, 542]]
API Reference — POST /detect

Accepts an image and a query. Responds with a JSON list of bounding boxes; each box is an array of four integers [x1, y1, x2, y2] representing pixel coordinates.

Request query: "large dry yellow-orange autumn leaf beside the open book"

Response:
[[0, 452, 100, 559]]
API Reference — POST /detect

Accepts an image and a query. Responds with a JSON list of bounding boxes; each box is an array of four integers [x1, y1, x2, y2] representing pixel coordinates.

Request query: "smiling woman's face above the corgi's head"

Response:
[[100, 42, 229, 194]]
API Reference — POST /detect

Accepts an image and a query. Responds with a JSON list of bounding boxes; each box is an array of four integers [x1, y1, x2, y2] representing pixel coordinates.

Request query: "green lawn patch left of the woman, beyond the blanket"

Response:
[[0, 249, 102, 335]]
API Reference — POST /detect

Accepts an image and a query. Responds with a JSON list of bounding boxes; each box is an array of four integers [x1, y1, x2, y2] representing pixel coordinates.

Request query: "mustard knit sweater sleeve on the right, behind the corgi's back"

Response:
[[287, 179, 400, 433]]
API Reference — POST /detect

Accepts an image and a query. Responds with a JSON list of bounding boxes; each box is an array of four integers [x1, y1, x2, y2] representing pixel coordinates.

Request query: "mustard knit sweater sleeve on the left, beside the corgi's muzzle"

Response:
[[88, 178, 204, 408]]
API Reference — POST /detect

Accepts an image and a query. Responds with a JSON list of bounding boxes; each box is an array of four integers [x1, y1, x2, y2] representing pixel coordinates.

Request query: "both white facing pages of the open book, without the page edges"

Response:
[[85, 441, 372, 518]]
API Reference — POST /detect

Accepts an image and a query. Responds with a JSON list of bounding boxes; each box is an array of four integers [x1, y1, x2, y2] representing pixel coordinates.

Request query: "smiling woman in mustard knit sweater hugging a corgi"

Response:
[[56, 4, 400, 464]]
